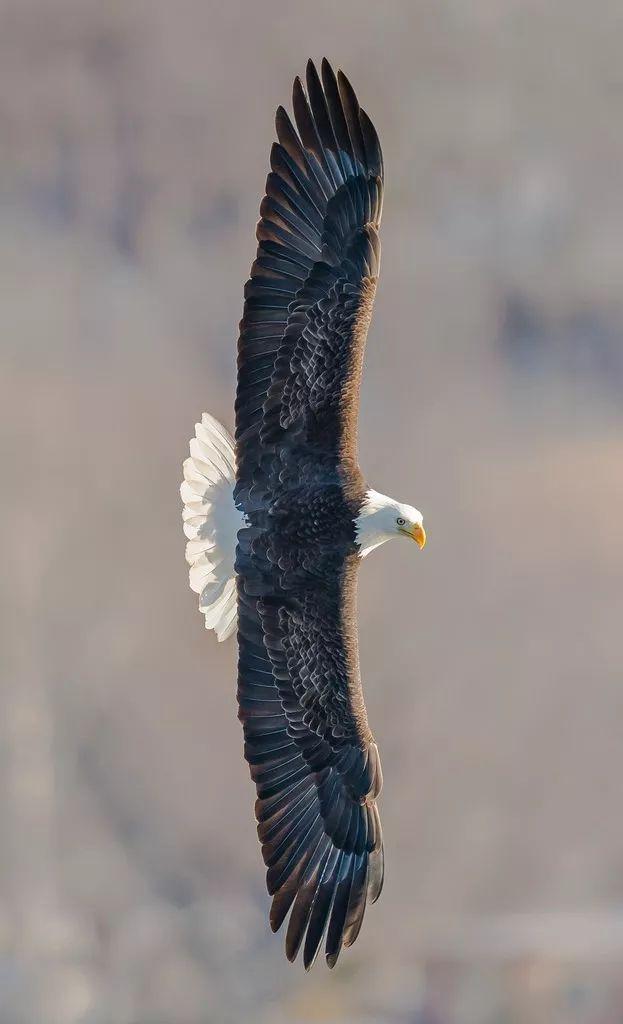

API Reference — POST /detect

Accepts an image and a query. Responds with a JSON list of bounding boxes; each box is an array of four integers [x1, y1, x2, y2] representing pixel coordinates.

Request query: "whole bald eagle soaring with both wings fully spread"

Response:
[[181, 60, 425, 969]]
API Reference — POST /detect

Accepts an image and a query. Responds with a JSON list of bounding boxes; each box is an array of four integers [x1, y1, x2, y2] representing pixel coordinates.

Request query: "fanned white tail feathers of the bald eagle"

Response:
[[180, 413, 244, 640]]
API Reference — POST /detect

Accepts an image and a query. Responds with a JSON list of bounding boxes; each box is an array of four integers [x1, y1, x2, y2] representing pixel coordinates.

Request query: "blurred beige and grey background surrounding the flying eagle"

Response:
[[0, 0, 623, 1024]]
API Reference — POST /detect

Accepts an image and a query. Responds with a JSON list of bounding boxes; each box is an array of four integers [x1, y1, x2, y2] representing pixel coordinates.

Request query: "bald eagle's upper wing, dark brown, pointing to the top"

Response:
[[236, 60, 383, 496]]
